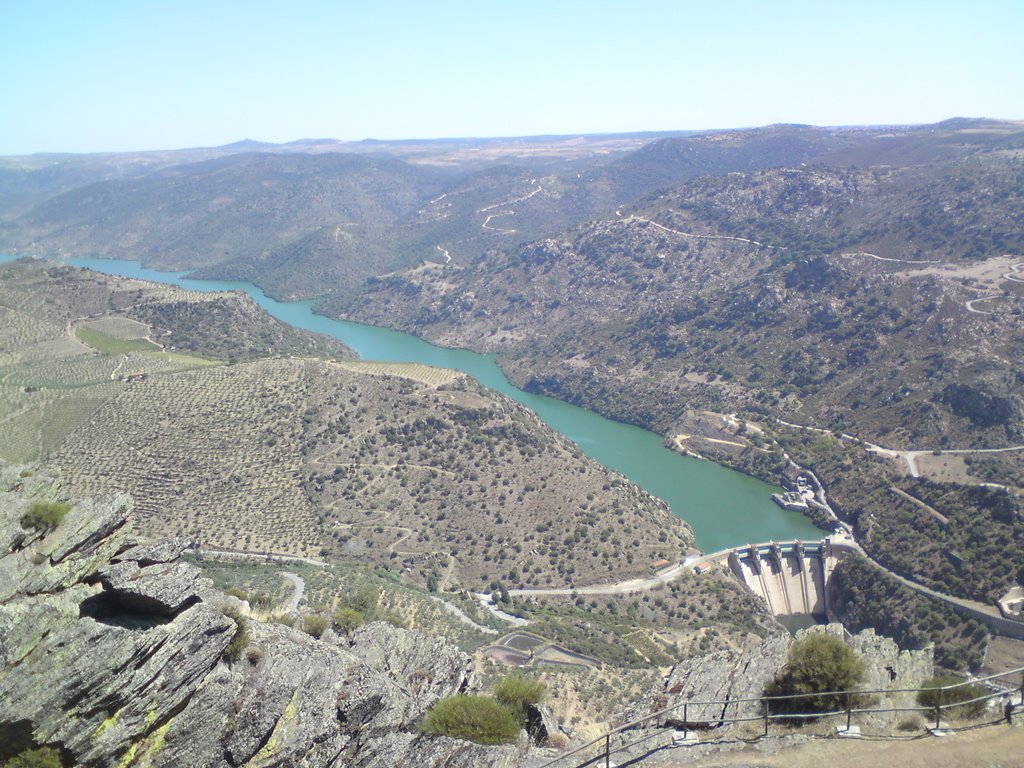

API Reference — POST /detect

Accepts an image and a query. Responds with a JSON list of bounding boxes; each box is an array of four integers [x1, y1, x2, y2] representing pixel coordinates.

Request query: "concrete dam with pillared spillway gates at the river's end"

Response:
[[709, 539, 848, 617]]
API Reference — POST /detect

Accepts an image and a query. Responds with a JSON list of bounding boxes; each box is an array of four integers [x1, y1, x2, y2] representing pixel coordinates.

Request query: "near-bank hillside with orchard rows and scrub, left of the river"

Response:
[[0, 262, 693, 588]]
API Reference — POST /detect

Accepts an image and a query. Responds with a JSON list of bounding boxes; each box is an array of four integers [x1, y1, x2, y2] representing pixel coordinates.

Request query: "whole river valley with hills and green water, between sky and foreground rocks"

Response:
[[0, 120, 1024, 757]]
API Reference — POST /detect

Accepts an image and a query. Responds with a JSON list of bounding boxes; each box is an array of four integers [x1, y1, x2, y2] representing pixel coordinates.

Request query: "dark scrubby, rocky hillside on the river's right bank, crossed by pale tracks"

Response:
[[348, 165, 1024, 445]]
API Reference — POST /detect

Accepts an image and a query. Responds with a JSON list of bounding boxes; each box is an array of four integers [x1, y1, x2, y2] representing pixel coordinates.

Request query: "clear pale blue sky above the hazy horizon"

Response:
[[0, 0, 1024, 155]]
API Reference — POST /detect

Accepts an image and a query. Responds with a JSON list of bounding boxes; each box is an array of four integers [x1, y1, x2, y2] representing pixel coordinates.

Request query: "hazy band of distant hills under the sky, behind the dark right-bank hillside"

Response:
[[9, 120, 1024, 306]]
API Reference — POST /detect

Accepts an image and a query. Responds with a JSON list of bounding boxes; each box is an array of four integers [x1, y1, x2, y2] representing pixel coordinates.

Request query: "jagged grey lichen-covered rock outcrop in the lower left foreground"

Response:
[[0, 475, 528, 768]]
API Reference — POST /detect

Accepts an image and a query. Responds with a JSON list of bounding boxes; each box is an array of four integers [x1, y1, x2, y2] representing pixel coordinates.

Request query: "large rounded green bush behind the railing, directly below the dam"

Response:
[[765, 633, 864, 714]]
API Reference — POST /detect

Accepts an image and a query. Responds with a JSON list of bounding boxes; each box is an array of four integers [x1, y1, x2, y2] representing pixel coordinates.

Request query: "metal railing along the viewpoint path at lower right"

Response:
[[540, 667, 1024, 768]]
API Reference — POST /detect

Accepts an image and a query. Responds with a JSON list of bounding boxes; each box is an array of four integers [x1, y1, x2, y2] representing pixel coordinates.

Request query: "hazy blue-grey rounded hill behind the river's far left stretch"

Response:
[[4, 154, 437, 294]]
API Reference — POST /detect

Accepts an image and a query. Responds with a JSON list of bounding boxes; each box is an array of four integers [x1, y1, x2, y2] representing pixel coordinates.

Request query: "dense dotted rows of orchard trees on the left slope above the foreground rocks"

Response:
[[52, 360, 319, 555]]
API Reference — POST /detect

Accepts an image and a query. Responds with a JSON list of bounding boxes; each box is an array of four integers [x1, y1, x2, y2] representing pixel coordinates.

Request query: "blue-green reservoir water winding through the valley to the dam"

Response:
[[0, 255, 822, 552]]
